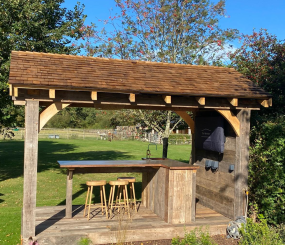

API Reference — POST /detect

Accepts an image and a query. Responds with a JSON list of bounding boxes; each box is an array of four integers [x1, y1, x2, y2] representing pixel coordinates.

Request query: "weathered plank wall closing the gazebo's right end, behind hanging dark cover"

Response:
[[194, 111, 236, 219]]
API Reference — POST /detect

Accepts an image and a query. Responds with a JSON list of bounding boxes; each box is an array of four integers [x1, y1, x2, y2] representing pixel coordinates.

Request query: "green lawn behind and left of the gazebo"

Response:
[[0, 139, 191, 245]]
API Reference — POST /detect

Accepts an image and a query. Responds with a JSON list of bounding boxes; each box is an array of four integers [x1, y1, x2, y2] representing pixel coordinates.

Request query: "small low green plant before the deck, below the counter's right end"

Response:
[[171, 228, 216, 245]]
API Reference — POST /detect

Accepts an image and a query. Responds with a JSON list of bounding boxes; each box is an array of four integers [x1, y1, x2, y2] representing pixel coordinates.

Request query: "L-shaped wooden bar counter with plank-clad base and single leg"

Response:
[[58, 158, 199, 224]]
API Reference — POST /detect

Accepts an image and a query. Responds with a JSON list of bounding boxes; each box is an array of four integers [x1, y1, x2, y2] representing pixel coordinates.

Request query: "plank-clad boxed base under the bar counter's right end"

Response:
[[142, 168, 196, 224]]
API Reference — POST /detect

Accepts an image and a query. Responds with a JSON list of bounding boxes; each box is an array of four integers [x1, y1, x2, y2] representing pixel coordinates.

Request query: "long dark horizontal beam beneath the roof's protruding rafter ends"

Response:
[[13, 89, 260, 111]]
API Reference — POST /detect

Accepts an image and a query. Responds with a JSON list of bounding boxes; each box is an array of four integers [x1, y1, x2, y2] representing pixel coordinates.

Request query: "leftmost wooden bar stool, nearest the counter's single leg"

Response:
[[83, 180, 108, 220]]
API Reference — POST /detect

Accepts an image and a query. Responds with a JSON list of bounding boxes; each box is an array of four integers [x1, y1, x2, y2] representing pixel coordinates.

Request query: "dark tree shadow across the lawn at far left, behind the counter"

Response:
[[0, 140, 131, 181]]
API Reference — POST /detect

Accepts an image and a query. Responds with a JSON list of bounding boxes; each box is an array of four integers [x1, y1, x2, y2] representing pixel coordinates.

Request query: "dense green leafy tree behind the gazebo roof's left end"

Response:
[[0, 0, 86, 127]]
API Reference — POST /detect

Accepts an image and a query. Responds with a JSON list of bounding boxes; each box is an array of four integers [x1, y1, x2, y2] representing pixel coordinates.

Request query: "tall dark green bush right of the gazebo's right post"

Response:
[[248, 117, 285, 225]]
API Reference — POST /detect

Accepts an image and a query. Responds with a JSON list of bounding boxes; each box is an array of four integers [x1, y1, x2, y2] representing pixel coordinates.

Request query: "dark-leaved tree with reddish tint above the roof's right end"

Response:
[[230, 29, 285, 120]]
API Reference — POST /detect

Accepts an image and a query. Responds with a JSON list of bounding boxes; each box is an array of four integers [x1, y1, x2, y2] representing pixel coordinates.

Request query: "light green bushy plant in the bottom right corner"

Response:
[[239, 219, 284, 245]]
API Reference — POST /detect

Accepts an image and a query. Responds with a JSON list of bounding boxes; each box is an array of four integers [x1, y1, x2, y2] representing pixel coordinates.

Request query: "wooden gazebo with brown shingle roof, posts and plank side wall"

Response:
[[9, 51, 272, 244]]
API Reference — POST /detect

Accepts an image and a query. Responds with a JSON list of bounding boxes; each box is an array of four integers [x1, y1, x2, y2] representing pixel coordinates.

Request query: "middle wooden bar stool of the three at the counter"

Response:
[[108, 180, 131, 218]]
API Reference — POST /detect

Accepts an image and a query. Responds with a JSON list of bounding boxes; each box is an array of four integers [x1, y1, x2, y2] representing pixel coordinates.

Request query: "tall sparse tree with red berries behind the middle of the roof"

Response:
[[81, 0, 238, 157]]
